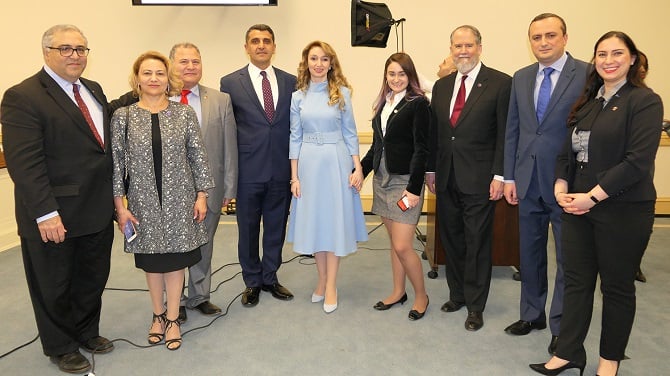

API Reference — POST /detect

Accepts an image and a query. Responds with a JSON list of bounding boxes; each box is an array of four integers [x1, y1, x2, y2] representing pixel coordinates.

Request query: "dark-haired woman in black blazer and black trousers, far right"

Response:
[[530, 31, 663, 376]]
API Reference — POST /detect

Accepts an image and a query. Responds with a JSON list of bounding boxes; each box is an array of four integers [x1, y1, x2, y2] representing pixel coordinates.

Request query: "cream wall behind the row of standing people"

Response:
[[0, 0, 670, 248]]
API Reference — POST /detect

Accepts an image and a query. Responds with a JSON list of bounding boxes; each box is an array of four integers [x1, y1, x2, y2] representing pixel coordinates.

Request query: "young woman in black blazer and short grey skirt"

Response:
[[361, 53, 430, 320]]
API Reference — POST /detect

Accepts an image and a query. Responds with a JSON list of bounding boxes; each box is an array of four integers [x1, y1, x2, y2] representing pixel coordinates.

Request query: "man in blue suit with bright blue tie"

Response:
[[504, 13, 588, 353]]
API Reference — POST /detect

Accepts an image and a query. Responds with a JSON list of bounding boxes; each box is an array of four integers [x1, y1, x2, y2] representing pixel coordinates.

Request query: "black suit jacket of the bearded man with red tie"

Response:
[[427, 64, 512, 194]]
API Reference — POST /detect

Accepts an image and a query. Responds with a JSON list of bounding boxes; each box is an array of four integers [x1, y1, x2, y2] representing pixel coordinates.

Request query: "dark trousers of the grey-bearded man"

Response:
[[437, 171, 495, 312]]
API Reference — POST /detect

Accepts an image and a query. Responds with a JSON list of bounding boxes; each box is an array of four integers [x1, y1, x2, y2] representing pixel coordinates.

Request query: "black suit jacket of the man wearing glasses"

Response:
[[0, 70, 114, 239]]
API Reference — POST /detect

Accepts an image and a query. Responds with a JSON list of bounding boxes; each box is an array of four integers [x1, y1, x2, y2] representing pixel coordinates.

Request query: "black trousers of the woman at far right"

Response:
[[556, 200, 654, 362]]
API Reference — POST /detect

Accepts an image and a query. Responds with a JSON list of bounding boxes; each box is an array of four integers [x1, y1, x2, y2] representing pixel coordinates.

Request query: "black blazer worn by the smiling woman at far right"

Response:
[[556, 83, 663, 202]]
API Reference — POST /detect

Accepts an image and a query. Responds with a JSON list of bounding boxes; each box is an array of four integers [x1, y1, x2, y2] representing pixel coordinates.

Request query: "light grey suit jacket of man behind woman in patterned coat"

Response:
[[198, 85, 237, 212]]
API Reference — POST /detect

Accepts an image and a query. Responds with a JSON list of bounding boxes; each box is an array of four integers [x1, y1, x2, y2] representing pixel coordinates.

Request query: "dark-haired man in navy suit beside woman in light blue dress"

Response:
[[221, 24, 296, 307]]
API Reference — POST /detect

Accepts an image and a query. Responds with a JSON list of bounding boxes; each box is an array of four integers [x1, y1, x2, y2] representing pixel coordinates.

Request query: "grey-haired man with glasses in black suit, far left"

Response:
[[0, 25, 114, 373]]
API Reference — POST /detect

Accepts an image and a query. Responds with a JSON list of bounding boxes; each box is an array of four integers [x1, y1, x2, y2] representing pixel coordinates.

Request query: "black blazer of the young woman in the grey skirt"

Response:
[[361, 97, 430, 196]]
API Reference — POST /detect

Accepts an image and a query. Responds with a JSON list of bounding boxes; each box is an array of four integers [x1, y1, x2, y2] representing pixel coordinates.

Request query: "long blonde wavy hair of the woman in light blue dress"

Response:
[[296, 40, 353, 110]]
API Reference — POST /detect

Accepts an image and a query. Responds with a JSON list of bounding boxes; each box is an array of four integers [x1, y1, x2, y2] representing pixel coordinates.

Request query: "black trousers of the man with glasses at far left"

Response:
[[21, 220, 114, 356]]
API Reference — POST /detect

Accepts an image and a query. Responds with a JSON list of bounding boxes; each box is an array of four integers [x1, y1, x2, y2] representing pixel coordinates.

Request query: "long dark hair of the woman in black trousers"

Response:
[[568, 31, 647, 125]]
